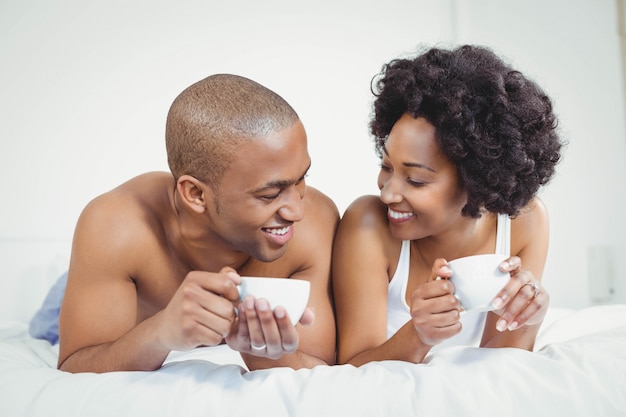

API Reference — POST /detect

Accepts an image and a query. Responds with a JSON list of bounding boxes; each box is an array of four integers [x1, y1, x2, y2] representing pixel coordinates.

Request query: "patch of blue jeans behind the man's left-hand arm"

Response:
[[28, 272, 67, 345]]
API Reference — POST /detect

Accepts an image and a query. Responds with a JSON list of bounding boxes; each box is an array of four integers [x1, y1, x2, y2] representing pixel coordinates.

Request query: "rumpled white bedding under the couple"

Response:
[[0, 305, 626, 417]]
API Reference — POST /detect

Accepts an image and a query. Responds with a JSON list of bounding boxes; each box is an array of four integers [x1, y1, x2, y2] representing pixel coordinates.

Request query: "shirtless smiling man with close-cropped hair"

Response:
[[58, 74, 339, 372]]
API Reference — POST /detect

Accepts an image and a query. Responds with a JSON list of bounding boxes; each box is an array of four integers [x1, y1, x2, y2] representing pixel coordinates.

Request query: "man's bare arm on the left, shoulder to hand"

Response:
[[58, 196, 238, 372]]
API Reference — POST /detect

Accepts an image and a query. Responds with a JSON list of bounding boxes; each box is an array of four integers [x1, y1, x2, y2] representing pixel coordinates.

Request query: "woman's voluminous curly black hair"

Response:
[[370, 45, 563, 217]]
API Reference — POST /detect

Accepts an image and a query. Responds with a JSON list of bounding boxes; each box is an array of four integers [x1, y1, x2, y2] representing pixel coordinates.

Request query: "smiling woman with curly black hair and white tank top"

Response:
[[333, 46, 562, 366]]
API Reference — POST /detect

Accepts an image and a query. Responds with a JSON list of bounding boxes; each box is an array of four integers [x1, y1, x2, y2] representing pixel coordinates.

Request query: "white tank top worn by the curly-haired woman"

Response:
[[387, 214, 511, 352]]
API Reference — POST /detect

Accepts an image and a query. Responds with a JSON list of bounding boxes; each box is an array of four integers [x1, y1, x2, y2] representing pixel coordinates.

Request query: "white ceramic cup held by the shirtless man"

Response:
[[237, 277, 311, 326]]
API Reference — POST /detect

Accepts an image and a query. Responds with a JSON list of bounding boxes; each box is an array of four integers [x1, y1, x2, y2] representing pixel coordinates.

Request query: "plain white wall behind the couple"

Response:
[[0, 0, 626, 319]]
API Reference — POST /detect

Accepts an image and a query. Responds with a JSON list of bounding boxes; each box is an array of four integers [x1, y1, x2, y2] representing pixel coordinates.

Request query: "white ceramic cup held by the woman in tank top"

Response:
[[448, 253, 510, 311]]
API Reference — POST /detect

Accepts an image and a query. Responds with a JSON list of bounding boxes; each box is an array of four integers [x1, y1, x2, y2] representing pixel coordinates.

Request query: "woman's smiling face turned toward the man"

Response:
[[378, 114, 467, 240]]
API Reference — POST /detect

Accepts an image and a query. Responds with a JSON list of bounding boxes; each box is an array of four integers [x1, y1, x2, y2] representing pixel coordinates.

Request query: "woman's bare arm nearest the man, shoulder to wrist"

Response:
[[333, 196, 430, 366]]
